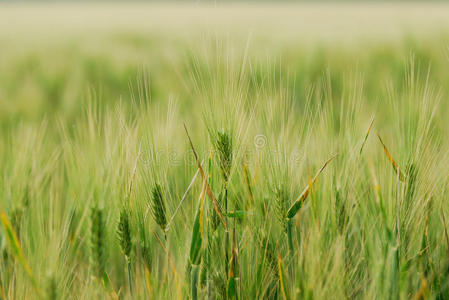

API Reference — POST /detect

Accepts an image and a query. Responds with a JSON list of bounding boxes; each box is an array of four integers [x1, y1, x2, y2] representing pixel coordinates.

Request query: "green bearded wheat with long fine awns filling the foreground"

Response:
[[0, 41, 449, 299]]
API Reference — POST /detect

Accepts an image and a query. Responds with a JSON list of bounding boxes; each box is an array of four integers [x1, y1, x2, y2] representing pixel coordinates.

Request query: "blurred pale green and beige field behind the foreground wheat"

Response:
[[0, 1, 449, 126]]
